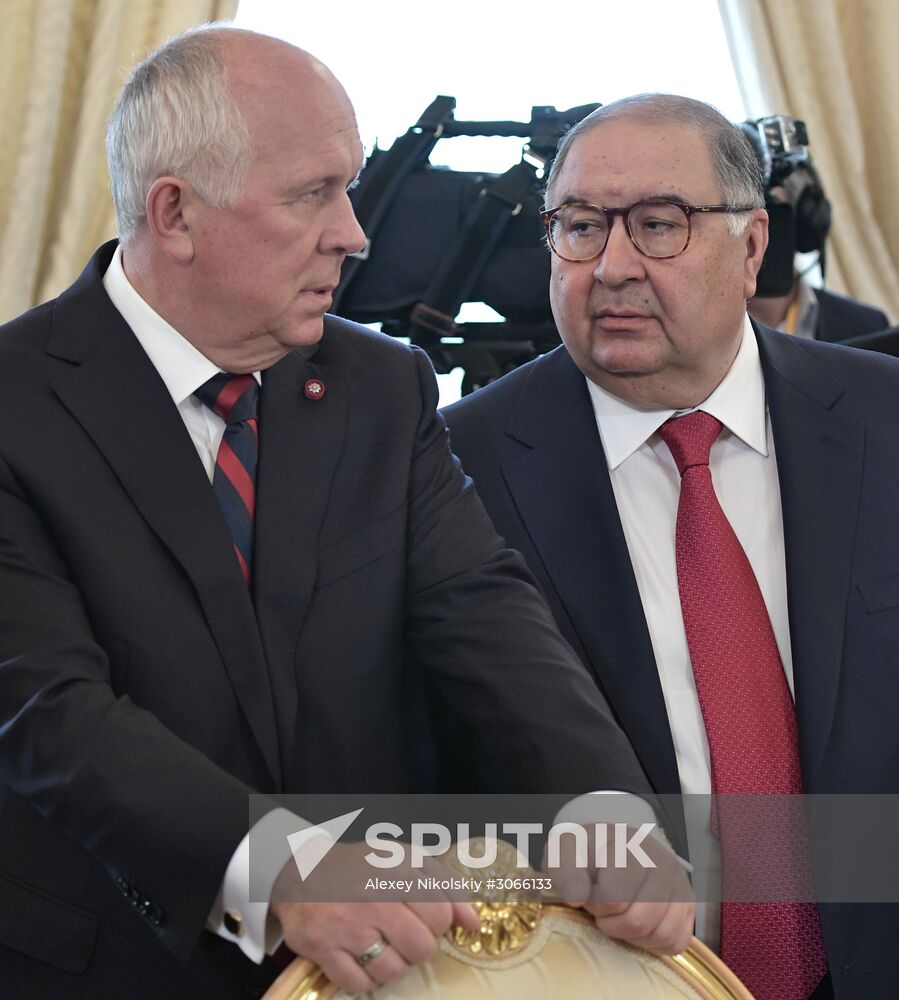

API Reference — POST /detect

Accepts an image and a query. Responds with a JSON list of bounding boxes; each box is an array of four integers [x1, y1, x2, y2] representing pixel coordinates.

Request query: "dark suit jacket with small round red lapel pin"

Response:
[[0, 244, 646, 998]]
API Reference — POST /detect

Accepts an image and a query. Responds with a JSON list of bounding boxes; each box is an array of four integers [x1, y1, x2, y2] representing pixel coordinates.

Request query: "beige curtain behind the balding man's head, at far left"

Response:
[[0, 0, 237, 322]]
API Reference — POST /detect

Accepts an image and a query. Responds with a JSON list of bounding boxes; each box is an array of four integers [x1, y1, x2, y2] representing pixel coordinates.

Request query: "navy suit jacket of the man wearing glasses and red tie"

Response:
[[445, 328, 899, 1000]]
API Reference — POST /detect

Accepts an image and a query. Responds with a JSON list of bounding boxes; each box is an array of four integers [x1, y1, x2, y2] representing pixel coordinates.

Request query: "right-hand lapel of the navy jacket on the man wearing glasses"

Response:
[[758, 328, 864, 790]]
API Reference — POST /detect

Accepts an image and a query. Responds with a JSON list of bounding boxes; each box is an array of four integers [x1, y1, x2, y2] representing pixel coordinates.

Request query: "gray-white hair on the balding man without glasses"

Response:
[[106, 22, 253, 243]]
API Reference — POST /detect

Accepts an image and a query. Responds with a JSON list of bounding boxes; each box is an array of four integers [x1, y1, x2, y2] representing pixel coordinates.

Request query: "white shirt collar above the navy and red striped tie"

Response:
[[103, 246, 260, 406]]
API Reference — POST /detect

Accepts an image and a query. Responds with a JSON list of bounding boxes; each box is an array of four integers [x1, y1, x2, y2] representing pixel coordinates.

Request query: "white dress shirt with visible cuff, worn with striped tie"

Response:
[[103, 247, 292, 962]]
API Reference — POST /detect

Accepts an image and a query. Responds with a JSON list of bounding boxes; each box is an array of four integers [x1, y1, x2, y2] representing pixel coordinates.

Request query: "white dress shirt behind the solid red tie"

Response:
[[587, 317, 793, 950]]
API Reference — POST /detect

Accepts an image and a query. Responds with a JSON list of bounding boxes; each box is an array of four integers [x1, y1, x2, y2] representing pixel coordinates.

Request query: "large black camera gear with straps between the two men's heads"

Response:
[[334, 96, 599, 392]]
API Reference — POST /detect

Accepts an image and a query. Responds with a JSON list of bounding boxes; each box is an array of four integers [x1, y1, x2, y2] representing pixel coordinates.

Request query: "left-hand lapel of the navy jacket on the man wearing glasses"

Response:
[[503, 348, 679, 792]]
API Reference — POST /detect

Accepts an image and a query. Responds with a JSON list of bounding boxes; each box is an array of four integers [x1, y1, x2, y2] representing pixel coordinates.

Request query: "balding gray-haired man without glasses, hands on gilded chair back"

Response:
[[0, 26, 693, 1000]]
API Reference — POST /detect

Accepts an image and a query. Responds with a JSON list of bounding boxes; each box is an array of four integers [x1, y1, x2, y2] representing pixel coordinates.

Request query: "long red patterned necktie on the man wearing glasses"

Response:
[[659, 411, 827, 1000]]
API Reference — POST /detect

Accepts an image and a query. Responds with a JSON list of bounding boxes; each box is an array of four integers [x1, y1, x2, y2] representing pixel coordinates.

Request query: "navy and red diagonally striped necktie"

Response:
[[194, 372, 259, 587]]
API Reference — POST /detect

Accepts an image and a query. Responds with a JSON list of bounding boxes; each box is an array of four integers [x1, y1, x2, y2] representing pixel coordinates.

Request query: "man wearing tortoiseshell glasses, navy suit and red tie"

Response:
[[446, 95, 899, 1000]]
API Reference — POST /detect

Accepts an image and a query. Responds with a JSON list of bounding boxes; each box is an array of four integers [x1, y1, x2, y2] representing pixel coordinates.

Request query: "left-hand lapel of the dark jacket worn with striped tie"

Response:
[[48, 246, 280, 785]]
